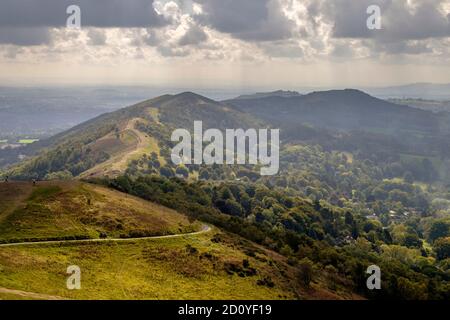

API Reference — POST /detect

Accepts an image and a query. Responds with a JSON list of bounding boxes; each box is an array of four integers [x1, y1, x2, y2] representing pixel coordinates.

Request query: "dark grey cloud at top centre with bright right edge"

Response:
[[197, 0, 294, 41]]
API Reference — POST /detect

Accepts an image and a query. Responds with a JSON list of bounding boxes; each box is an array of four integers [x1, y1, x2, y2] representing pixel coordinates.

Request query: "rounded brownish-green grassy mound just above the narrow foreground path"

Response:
[[0, 182, 201, 242]]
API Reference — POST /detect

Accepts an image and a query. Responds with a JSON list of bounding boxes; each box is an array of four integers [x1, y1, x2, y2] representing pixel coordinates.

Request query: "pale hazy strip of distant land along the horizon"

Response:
[[0, 83, 450, 101]]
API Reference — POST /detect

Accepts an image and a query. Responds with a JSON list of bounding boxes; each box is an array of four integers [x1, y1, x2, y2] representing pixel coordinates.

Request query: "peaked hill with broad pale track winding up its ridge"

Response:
[[0, 92, 266, 180]]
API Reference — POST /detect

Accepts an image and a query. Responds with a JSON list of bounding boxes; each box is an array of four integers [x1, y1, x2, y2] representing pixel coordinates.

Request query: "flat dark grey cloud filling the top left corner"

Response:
[[0, 0, 167, 29]]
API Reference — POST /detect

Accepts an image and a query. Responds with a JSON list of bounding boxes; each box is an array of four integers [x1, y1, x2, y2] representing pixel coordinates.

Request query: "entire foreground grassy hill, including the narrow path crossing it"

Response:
[[0, 181, 352, 299]]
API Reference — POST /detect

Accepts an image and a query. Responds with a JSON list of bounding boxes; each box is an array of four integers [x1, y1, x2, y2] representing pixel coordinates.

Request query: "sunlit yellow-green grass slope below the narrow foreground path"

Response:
[[0, 229, 352, 299]]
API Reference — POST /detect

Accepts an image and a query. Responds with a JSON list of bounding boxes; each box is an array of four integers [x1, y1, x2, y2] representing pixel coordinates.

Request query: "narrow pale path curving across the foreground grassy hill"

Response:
[[0, 224, 212, 248]]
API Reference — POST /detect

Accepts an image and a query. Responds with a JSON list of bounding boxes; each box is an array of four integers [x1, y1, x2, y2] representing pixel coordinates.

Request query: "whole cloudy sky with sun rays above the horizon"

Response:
[[0, 0, 450, 89]]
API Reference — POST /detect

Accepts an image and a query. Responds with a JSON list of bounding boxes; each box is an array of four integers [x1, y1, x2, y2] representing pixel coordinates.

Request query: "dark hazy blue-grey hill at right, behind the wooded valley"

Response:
[[225, 89, 440, 134]]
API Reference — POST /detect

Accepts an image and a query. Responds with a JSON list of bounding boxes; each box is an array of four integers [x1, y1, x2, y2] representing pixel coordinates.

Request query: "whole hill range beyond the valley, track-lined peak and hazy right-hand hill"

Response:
[[0, 89, 450, 179]]
